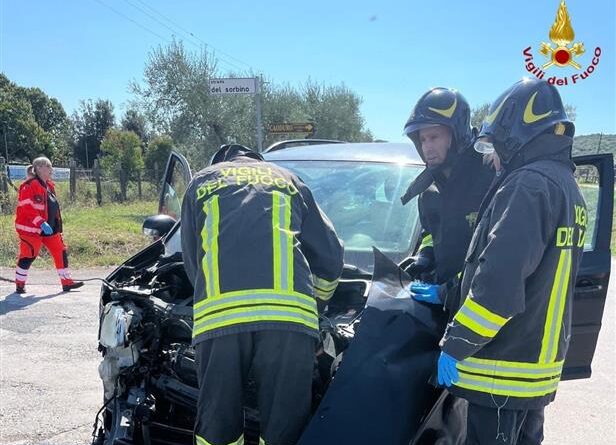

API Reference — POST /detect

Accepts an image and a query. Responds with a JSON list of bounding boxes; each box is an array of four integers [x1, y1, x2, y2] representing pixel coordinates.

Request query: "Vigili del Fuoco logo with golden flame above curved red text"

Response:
[[522, 0, 601, 86]]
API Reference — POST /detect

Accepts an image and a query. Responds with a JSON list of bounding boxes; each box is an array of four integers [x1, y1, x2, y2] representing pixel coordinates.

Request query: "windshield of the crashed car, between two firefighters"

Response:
[[274, 160, 423, 273]]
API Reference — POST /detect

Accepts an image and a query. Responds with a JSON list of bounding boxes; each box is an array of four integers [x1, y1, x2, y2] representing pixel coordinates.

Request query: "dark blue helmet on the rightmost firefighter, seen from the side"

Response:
[[478, 78, 575, 164]]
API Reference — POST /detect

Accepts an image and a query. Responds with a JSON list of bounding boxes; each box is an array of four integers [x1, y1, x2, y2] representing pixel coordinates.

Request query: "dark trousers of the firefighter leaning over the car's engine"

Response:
[[195, 330, 315, 445]]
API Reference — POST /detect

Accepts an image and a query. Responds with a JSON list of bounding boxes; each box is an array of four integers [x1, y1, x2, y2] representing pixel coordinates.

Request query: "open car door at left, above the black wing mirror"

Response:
[[158, 151, 192, 220]]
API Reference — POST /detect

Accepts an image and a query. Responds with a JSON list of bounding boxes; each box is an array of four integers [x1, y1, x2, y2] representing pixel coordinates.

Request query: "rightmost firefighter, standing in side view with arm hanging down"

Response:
[[438, 79, 587, 445]]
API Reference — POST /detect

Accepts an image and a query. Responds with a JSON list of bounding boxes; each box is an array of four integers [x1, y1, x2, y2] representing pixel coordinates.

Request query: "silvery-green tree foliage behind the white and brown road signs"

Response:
[[131, 41, 372, 168]]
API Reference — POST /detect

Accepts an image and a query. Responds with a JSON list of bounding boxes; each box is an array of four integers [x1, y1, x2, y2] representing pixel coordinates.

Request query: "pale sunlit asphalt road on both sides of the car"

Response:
[[0, 261, 616, 445]]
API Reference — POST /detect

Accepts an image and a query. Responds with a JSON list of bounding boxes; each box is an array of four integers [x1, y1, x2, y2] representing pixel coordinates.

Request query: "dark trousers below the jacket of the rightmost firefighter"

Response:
[[466, 403, 544, 445]]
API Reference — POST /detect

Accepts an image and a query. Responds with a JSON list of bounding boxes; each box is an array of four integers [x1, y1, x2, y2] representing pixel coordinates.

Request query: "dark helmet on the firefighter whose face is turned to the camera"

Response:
[[404, 87, 473, 159]]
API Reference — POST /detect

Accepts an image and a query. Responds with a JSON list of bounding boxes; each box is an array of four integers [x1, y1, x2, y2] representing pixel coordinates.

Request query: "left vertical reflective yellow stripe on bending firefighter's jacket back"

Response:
[[201, 195, 220, 297]]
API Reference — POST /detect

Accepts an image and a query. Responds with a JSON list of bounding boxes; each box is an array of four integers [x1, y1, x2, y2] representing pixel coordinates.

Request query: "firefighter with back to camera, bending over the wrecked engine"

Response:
[[181, 145, 343, 445]]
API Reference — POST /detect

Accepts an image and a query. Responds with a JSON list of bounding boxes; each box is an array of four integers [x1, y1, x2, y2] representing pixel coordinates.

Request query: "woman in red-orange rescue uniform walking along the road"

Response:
[[15, 156, 83, 294]]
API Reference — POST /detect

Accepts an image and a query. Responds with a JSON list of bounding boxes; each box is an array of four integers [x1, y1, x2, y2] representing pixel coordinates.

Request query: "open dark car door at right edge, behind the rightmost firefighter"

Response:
[[563, 154, 614, 380]]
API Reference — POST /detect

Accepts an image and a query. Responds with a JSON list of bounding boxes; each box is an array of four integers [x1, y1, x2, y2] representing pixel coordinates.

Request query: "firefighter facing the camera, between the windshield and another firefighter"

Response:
[[401, 88, 494, 305]]
